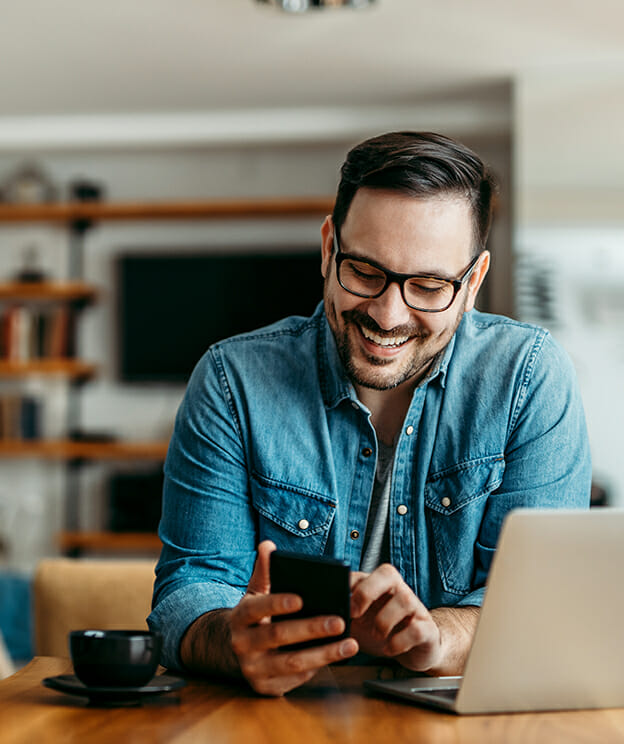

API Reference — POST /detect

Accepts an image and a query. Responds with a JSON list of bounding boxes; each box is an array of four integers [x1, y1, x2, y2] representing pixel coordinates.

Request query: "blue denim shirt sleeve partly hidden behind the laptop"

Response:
[[470, 332, 591, 605]]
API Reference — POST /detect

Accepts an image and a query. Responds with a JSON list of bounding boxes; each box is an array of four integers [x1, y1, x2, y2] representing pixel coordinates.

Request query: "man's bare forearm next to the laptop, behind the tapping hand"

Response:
[[427, 607, 480, 677]]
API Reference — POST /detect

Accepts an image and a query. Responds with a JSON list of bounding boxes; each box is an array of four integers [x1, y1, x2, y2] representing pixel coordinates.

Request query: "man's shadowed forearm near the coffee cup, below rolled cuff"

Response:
[[180, 609, 241, 677]]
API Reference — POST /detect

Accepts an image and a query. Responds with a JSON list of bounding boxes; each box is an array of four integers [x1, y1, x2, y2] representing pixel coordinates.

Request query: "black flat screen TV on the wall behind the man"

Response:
[[116, 247, 323, 383]]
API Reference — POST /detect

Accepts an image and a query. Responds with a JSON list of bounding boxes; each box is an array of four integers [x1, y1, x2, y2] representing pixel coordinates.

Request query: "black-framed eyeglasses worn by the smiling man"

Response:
[[334, 230, 480, 313]]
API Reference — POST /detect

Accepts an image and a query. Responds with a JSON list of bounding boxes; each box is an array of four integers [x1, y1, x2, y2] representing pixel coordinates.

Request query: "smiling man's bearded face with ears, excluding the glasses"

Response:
[[321, 189, 489, 390]]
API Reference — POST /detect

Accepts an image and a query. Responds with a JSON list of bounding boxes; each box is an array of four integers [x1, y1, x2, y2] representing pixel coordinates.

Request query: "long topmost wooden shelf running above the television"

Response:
[[0, 196, 334, 222]]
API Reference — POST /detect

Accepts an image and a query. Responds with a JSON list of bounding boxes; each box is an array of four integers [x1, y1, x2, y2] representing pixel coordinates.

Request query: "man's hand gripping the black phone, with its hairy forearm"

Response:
[[181, 540, 358, 695]]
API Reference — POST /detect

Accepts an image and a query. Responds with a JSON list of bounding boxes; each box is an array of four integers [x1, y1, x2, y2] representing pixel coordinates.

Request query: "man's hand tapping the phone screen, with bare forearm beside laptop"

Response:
[[351, 564, 478, 675]]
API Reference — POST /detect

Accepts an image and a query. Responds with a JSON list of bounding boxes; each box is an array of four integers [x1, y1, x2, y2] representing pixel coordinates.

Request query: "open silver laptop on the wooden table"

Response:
[[366, 508, 624, 713]]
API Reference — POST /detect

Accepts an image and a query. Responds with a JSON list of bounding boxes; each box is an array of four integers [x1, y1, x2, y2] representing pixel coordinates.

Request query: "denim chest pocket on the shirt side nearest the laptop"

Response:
[[425, 455, 505, 595]]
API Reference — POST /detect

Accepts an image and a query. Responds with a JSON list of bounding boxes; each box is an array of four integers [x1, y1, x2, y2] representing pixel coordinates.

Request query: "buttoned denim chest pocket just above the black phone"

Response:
[[251, 472, 336, 555]]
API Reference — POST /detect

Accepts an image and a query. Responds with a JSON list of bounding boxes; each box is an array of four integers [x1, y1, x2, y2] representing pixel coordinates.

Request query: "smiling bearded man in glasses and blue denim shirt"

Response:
[[149, 132, 590, 695]]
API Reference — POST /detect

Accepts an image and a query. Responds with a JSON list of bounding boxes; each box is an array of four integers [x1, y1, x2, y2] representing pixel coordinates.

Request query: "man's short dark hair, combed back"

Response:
[[332, 132, 496, 255]]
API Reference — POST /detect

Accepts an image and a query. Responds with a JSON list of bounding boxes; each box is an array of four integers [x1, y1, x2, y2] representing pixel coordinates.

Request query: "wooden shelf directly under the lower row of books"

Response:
[[0, 439, 169, 461]]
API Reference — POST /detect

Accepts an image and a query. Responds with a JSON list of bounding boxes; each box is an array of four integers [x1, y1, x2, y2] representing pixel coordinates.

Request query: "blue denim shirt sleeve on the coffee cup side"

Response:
[[148, 350, 256, 669]]
